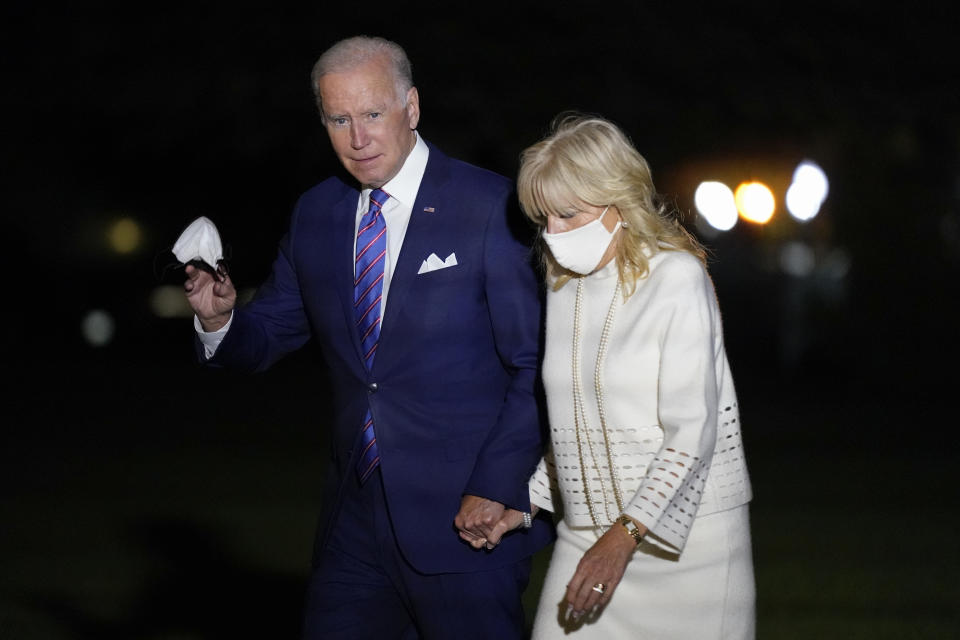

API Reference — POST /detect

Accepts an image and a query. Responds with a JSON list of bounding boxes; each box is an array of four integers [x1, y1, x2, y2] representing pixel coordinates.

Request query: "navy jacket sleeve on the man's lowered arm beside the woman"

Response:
[[464, 192, 543, 511]]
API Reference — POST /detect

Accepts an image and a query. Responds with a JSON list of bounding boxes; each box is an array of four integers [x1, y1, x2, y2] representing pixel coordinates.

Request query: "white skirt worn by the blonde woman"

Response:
[[533, 505, 756, 640]]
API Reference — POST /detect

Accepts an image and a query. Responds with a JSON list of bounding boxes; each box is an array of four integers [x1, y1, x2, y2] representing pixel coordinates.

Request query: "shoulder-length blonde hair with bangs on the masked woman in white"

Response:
[[517, 113, 706, 297]]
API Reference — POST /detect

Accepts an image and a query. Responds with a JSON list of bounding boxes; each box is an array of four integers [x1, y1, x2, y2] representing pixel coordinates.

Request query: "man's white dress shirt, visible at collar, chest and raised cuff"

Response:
[[193, 131, 430, 359]]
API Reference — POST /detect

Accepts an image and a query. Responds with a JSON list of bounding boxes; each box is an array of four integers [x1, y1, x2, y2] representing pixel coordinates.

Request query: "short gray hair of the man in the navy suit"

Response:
[[310, 36, 413, 118]]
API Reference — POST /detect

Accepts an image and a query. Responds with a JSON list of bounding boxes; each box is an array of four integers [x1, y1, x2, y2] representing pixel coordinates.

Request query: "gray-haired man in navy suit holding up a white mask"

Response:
[[185, 36, 552, 640]]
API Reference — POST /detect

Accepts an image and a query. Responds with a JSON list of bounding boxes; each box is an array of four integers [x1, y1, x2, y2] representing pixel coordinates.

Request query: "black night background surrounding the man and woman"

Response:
[[0, 0, 960, 640]]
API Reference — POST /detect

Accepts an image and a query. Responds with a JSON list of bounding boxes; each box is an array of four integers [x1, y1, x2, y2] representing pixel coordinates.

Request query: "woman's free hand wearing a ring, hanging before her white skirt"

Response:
[[565, 524, 637, 620]]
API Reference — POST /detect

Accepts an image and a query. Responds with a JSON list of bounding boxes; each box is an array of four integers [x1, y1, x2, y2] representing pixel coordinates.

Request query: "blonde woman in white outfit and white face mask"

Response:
[[476, 115, 754, 640]]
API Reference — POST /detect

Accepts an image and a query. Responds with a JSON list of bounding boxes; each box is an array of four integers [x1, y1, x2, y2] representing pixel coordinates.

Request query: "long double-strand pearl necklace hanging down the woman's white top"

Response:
[[573, 276, 623, 529]]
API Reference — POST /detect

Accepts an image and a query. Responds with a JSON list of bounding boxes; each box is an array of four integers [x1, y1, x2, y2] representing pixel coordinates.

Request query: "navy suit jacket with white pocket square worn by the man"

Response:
[[211, 145, 553, 573]]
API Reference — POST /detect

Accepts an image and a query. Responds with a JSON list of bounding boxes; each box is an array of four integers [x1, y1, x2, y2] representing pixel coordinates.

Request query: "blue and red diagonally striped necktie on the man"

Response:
[[353, 189, 390, 482]]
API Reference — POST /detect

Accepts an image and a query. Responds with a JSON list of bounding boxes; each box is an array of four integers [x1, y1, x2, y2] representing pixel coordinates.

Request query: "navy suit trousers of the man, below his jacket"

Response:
[[303, 468, 531, 640]]
